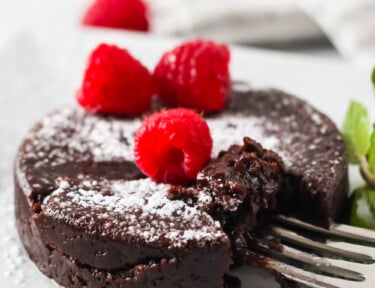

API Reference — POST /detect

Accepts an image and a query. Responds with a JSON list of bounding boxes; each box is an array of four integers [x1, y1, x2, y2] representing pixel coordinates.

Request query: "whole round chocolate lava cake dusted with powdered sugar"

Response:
[[15, 90, 348, 288]]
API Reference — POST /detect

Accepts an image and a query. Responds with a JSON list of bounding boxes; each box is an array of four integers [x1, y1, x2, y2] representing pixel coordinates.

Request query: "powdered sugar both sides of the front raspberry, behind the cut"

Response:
[[25, 107, 292, 171]]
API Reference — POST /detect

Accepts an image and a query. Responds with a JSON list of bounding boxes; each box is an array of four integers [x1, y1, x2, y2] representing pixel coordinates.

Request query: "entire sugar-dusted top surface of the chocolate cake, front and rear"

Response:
[[16, 90, 347, 247]]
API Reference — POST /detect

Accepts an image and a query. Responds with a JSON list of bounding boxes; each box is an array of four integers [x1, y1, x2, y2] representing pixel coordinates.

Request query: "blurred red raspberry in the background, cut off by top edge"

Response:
[[82, 0, 149, 31]]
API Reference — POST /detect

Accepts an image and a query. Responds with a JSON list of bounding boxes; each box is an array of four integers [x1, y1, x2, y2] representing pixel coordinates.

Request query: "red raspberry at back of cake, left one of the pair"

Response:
[[77, 44, 153, 115]]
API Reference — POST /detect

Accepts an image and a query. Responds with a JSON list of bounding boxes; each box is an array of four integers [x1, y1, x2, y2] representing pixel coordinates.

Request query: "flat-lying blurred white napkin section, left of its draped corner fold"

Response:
[[147, 0, 323, 44]]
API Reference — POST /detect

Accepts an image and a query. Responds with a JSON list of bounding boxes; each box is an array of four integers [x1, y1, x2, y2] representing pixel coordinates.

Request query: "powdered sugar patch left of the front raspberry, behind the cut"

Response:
[[25, 107, 141, 166]]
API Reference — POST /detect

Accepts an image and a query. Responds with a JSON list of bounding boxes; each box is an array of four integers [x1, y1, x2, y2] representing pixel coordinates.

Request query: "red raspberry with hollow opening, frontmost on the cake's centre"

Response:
[[134, 108, 212, 184]]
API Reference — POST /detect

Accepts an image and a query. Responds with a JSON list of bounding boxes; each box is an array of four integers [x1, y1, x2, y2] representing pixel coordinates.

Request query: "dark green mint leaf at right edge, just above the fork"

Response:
[[350, 186, 375, 230]]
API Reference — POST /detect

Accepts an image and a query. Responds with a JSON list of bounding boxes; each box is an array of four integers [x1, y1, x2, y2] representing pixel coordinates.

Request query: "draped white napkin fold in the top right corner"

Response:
[[298, 0, 375, 66]]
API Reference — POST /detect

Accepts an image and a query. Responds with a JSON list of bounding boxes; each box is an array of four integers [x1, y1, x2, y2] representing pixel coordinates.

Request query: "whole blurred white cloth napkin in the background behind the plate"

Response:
[[148, 0, 375, 65]]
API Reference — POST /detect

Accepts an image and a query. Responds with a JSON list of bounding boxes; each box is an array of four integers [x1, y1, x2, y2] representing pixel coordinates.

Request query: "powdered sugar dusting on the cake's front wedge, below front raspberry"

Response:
[[43, 179, 227, 247]]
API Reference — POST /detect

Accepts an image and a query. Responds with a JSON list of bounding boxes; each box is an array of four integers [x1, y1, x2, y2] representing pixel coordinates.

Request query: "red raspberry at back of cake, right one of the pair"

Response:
[[154, 40, 231, 111]]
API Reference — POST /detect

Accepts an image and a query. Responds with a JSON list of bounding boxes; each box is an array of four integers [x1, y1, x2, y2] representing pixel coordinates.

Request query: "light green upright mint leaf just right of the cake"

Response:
[[343, 101, 371, 164]]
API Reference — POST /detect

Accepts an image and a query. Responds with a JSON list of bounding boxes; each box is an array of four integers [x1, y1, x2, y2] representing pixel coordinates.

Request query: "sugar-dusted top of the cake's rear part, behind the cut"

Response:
[[17, 90, 346, 189]]
